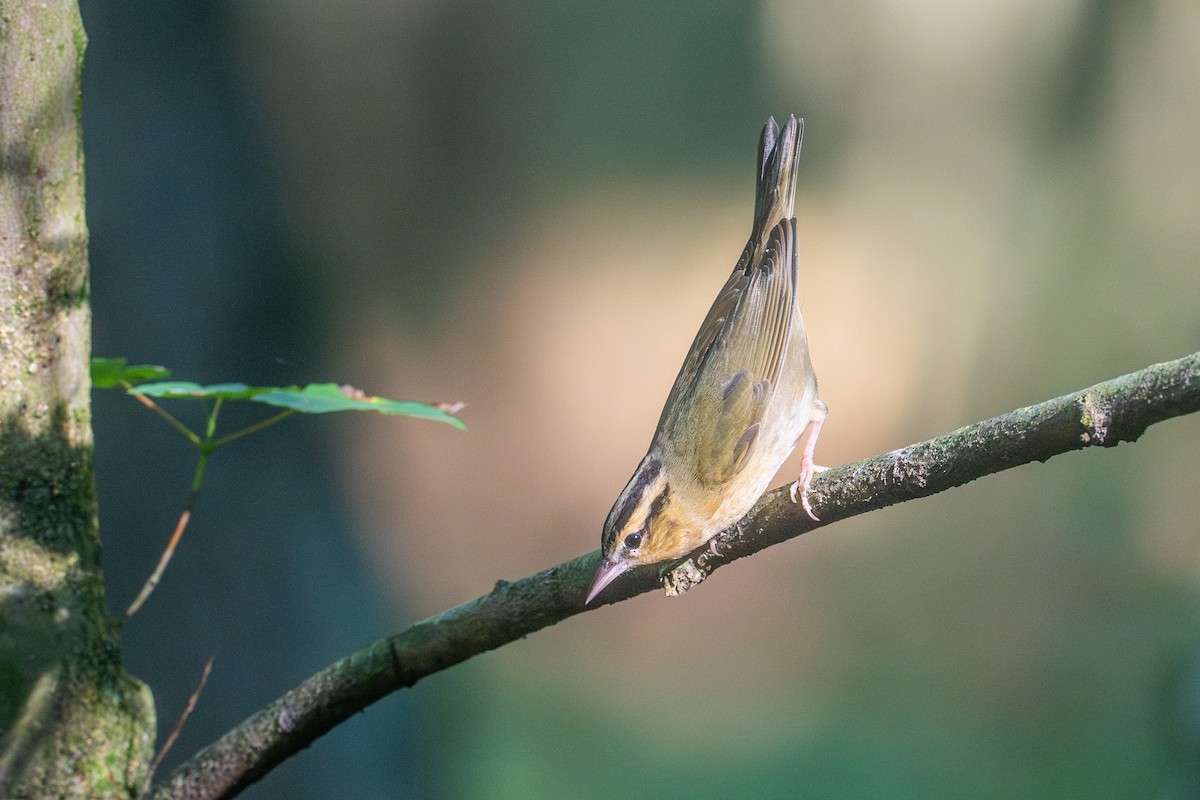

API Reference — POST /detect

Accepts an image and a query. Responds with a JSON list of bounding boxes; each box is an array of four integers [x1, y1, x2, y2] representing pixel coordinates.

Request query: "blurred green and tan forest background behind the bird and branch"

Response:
[[82, 0, 1200, 800]]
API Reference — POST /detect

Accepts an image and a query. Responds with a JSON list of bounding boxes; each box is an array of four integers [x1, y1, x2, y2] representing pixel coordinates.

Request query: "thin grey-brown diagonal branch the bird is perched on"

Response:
[[154, 353, 1200, 799]]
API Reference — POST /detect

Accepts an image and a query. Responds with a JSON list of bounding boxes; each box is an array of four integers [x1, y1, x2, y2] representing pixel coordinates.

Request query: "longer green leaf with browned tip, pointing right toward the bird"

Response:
[[130, 380, 467, 429]]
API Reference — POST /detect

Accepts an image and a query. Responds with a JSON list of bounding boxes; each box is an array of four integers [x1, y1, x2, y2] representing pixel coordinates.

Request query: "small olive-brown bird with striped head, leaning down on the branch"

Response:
[[584, 115, 829, 604]]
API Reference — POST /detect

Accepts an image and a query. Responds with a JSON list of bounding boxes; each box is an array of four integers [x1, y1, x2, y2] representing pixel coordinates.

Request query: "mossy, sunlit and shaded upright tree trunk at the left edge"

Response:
[[0, 0, 155, 799]]
